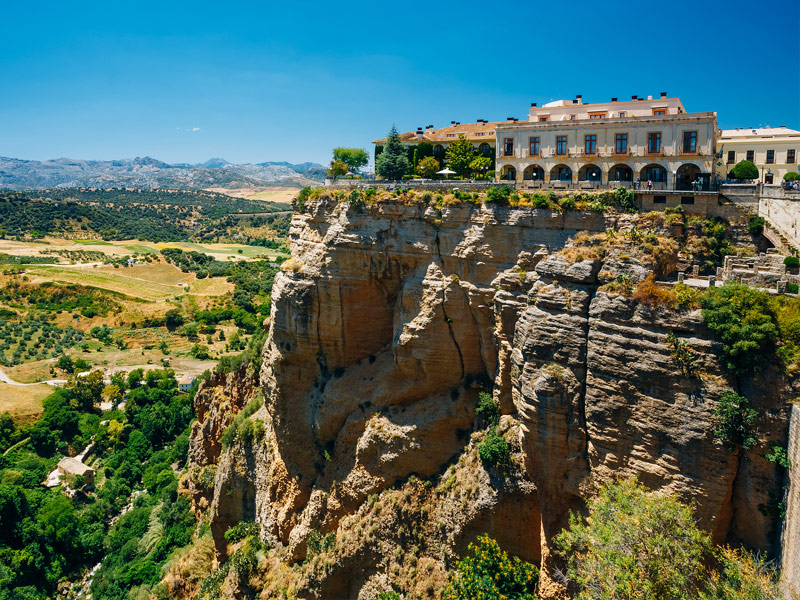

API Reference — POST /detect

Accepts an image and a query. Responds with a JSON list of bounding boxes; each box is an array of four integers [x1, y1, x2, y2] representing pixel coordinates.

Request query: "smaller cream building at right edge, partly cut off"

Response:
[[716, 126, 800, 183]]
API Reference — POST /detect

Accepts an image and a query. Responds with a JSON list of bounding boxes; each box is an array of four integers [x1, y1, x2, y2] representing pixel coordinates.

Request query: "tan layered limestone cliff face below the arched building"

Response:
[[192, 199, 787, 599]]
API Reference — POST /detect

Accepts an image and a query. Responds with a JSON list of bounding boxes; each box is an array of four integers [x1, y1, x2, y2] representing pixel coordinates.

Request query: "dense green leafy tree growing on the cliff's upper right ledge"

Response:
[[700, 281, 778, 375]]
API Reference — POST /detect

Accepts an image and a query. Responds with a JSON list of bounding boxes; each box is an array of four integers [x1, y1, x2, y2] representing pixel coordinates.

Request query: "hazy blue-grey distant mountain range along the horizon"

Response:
[[0, 156, 325, 190]]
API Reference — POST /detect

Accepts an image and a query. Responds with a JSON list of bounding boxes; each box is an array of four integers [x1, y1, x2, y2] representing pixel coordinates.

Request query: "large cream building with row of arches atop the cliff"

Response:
[[496, 93, 717, 190]]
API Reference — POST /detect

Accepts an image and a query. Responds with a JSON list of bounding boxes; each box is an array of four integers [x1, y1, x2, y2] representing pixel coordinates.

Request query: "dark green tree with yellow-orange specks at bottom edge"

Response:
[[442, 534, 539, 600]]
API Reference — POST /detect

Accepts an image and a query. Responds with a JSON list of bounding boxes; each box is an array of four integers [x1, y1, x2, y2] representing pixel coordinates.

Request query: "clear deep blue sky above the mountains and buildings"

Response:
[[0, 0, 800, 162]]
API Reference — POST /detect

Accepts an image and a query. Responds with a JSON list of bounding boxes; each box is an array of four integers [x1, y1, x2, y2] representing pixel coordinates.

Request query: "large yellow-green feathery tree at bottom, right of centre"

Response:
[[556, 479, 710, 600]]
